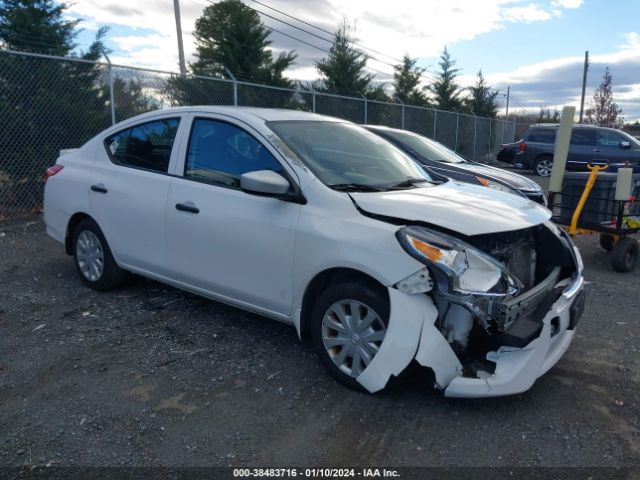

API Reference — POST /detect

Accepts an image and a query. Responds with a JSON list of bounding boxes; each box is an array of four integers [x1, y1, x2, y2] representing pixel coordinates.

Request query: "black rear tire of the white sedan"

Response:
[[73, 218, 127, 291]]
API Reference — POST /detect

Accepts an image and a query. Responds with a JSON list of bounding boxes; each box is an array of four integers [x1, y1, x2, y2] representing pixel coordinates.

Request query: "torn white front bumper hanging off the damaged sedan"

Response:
[[357, 247, 584, 398]]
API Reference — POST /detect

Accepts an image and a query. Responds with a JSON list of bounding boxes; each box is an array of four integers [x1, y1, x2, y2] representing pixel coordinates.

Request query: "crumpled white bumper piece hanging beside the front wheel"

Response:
[[357, 288, 462, 393]]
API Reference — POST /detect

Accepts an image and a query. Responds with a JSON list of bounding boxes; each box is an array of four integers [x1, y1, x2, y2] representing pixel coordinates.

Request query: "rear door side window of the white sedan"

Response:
[[105, 118, 180, 173]]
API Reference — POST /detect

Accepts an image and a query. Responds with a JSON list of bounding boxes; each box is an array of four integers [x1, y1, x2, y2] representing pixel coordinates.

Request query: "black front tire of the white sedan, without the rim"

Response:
[[310, 280, 389, 392]]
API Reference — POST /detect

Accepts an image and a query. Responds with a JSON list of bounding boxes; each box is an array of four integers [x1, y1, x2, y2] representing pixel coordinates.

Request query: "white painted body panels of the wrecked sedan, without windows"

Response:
[[45, 107, 582, 396]]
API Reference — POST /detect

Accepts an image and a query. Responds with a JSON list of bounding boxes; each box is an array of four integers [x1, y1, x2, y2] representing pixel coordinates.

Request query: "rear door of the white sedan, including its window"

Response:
[[90, 116, 181, 274]]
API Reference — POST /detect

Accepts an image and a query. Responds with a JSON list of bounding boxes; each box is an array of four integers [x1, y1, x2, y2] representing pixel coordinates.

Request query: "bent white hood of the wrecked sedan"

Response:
[[350, 181, 551, 235]]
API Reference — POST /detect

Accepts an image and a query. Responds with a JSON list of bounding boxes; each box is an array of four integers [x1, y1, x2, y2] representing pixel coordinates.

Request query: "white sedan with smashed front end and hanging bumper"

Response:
[[44, 107, 584, 397]]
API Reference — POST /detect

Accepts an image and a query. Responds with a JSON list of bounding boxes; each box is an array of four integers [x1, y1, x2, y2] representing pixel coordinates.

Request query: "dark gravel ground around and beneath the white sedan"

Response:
[[0, 173, 640, 467]]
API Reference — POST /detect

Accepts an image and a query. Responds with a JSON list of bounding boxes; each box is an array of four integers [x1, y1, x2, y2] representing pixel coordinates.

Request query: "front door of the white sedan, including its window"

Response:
[[166, 116, 300, 315]]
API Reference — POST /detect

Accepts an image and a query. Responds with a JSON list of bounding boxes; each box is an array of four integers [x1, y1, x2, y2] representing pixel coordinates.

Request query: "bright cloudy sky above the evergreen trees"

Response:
[[67, 0, 640, 121]]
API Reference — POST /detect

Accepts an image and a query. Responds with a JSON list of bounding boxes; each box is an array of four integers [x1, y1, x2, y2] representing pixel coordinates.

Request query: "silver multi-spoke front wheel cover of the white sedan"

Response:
[[322, 299, 387, 378]]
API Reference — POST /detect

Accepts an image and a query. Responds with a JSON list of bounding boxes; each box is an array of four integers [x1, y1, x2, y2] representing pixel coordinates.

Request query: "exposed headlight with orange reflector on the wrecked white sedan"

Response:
[[397, 226, 522, 297]]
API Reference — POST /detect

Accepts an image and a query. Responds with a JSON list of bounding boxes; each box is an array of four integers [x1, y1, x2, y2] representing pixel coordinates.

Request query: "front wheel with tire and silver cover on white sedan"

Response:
[[311, 283, 389, 391]]
